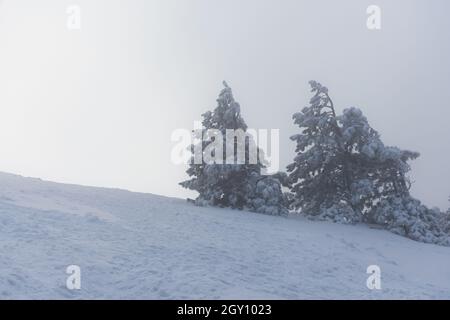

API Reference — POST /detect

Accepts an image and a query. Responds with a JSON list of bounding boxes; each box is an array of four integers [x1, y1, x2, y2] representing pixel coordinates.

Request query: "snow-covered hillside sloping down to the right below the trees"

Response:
[[0, 173, 450, 299]]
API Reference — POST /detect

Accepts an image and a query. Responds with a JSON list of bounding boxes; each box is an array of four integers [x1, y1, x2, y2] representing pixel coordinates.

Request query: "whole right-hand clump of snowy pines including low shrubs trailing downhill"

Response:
[[288, 81, 450, 245]]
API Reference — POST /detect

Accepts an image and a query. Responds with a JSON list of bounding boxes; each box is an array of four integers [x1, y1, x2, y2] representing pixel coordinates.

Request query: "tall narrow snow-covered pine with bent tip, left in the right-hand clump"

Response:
[[287, 81, 360, 223]]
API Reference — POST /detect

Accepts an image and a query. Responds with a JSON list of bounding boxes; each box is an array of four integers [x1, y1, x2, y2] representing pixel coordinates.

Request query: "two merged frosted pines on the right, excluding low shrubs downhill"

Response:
[[287, 81, 418, 223]]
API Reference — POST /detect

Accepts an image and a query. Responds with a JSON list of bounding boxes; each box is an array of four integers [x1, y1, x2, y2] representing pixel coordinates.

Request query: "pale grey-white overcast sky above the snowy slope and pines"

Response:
[[0, 0, 450, 208]]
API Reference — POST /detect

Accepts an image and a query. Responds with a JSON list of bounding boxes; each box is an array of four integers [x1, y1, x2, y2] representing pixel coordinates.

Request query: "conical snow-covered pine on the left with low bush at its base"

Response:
[[180, 82, 288, 215]]
